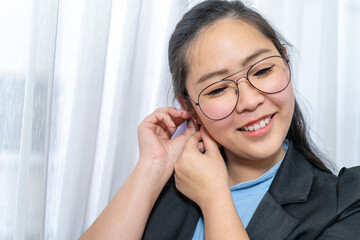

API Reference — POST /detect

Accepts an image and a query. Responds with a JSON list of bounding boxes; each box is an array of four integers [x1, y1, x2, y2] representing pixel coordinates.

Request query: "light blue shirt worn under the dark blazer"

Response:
[[192, 140, 289, 240]]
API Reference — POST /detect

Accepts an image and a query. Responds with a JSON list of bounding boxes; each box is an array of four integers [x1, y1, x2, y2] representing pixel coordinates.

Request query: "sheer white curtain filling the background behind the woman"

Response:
[[0, 0, 360, 239]]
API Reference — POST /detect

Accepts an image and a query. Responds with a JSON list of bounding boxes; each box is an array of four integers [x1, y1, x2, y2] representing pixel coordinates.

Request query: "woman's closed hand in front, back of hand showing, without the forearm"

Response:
[[175, 127, 229, 209]]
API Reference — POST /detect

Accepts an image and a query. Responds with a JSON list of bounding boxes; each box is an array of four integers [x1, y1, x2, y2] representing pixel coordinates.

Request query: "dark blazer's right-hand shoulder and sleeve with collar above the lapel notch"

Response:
[[270, 142, 360, 239]]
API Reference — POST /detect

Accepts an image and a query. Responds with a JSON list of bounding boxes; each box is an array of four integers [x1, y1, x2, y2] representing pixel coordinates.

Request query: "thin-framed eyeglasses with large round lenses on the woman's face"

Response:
[[188, 56, 291, 120]]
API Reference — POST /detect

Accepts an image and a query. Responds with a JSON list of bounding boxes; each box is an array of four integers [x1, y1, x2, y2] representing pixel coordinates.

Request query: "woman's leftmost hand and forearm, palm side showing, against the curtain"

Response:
[[81, 108, 196, 240]]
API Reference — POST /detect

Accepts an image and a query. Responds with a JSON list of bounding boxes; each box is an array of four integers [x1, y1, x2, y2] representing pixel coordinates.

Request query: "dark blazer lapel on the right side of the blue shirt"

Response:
[[246, 142, 313, 240]]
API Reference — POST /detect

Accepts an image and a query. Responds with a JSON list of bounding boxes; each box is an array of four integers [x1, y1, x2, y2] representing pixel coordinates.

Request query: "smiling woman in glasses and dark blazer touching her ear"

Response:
[[83, 1, 360, 239]]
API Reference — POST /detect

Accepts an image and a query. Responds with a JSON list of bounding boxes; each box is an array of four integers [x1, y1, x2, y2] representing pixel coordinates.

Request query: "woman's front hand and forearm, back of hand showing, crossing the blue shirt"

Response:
[[175, 127, 249, 239]]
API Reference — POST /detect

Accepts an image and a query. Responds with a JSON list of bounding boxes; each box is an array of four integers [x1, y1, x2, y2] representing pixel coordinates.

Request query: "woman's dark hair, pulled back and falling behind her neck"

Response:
[[168, 0, 328, 170]]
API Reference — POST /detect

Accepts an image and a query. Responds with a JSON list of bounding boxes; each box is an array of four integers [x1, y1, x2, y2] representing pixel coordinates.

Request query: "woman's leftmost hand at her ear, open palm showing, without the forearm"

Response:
[[138, 107, 195, 184]]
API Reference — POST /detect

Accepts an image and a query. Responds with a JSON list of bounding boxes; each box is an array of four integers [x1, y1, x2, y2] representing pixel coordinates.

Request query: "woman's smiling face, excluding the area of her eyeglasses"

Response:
[[186, 19, 294, 160]]
